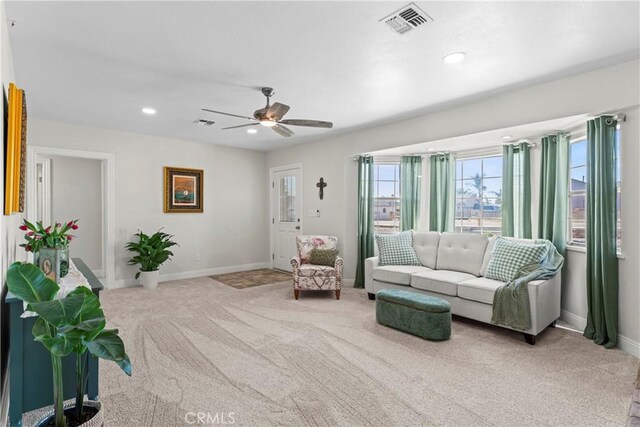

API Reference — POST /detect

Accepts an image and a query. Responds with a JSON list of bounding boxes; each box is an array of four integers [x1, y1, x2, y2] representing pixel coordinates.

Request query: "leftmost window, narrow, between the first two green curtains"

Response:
[[373, 163, 400, 234]]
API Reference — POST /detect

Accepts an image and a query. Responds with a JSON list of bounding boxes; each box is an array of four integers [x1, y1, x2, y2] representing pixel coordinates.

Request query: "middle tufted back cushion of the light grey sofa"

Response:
[[436, 233, 489, 276]]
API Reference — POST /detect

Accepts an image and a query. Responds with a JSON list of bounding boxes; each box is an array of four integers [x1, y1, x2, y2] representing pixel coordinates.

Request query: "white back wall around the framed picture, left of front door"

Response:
[[28, 119, 269, 286]]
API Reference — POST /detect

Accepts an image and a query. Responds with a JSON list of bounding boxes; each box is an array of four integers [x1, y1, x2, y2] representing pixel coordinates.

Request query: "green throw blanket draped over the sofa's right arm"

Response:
[[491, 240, 564, 331]]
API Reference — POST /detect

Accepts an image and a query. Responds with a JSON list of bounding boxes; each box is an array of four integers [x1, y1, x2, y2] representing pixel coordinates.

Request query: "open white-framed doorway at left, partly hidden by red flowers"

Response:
[[26, 146, 115, 288]]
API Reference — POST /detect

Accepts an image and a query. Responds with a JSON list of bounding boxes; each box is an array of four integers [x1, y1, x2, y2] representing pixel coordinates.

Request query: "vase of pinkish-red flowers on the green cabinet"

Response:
[[20, 219, 78, 283]]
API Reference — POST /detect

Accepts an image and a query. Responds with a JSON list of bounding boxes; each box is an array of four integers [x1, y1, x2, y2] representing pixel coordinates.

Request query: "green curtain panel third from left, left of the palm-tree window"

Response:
[[429, 153, 456, 231]]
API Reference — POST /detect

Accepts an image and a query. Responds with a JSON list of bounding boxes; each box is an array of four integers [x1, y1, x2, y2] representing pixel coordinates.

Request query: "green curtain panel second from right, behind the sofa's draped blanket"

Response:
[[538, 133, 570, 254]]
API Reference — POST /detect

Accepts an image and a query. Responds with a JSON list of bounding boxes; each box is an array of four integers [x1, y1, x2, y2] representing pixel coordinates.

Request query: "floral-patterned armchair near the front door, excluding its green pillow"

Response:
[[291, 236, 342, 299]]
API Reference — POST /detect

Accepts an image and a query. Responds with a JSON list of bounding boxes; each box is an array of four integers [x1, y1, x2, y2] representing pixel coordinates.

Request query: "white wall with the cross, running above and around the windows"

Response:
[[267, 61, 640, 354]]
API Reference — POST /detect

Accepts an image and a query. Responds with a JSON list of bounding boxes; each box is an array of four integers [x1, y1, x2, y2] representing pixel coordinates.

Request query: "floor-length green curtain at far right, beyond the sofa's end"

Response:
[[584, 116, 618, 348]]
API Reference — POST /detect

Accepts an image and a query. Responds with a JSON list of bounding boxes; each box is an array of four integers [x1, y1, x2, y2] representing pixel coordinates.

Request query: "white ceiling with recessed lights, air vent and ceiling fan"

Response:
[[6, 1, 640, 150]]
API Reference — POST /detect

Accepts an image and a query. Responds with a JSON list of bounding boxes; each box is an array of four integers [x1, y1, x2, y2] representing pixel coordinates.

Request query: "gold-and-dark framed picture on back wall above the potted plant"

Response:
[[164, 166, 204, 213]]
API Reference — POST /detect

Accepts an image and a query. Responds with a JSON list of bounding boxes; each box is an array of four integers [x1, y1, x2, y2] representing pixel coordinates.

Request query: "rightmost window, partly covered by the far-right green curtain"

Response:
[[567, 127, 622, 252]]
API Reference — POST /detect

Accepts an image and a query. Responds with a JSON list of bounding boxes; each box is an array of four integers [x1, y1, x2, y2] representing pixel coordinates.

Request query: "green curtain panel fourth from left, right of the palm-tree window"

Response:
[[502, 142, 531, 239]]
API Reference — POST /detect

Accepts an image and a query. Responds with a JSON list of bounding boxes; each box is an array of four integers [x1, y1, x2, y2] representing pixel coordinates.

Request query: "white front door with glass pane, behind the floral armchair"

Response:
[[271, 168, 302, 271]]
